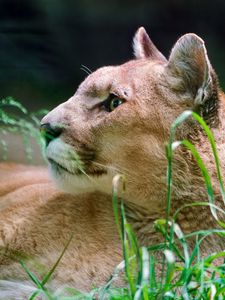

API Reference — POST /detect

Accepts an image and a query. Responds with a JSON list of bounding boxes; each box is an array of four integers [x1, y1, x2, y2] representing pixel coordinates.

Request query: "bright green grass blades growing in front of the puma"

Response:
[[0, 102, 225, 300]]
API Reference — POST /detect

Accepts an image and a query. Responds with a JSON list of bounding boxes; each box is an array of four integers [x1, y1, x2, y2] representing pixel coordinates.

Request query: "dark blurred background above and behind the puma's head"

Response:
[[0, 0, 225, 110]]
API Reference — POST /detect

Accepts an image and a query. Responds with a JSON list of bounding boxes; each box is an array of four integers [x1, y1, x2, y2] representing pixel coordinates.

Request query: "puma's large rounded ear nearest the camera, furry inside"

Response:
[[167, 33, 216, 104]]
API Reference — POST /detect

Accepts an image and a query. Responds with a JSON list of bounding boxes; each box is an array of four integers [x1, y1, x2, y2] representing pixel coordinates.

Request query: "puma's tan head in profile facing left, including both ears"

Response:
[[41, 28, 221, 211]]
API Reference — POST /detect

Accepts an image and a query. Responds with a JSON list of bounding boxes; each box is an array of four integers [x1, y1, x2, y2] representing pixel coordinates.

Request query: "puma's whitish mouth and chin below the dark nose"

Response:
[[46, 139, 114, 194]]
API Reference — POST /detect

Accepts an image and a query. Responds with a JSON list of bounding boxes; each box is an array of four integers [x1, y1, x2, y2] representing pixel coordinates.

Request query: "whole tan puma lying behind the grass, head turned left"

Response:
[[0, 28, 225, 291]]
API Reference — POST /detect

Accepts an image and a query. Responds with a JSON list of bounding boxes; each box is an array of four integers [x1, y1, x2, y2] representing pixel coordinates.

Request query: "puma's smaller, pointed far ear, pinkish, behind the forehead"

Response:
[[133, 27, 167, 62]]
